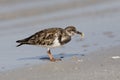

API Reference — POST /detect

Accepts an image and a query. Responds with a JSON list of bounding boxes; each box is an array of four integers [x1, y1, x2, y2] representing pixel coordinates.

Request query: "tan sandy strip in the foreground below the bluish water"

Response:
[[0, 46, 120, 80]]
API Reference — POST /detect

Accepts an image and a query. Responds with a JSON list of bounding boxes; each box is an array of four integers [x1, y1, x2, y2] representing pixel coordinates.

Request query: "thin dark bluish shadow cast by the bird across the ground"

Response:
[[18, 53, 84, 61]]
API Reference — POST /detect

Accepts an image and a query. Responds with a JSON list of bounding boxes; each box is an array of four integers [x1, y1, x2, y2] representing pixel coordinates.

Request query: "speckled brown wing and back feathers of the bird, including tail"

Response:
[[16, 28, 63, 47]]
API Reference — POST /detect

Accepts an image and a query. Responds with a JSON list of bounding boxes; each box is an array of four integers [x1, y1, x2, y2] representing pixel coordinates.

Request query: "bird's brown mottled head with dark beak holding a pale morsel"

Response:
[[65, 26, 84, 38]]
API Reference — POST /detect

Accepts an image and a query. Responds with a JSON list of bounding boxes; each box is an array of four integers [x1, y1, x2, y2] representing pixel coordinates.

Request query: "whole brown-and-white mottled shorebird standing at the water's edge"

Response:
[[16, 26, 84, 62]]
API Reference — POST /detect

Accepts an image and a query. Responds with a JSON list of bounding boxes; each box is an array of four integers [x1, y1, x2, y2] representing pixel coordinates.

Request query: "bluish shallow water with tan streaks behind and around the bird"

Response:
[[0, 0, 120, 71]]
